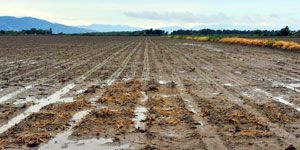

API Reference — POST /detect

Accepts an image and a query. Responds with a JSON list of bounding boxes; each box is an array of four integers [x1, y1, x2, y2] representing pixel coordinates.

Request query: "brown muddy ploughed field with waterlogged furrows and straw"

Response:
[[0, 36, 300, 150]]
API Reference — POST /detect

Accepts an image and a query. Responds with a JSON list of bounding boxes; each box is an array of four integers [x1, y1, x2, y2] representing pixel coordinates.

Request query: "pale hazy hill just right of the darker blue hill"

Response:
[[78, 24, 143, 32]]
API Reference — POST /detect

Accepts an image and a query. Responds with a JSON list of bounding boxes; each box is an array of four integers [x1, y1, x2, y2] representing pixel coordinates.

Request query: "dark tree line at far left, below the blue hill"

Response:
[[0, 28, 53, 35]]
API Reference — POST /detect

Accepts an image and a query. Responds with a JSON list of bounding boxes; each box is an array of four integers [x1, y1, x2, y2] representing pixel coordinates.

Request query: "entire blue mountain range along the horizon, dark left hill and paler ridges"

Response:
[[0, 16, 300, 33]]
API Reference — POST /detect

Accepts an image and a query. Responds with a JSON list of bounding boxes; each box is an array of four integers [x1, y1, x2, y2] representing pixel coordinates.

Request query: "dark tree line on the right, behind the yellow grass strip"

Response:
[[171, 26, 300, 36]]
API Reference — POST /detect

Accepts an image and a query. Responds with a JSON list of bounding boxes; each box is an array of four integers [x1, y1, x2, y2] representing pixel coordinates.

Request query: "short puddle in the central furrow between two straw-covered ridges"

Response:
[[132, 106, 148, 130]]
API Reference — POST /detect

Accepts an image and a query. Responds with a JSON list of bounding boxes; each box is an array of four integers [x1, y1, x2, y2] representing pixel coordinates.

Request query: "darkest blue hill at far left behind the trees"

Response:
[[0, 16, 93, 33]]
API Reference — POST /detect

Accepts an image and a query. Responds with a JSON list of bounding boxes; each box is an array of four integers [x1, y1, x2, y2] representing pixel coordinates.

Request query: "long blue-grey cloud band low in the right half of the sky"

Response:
[[124, 11, 300, 25]]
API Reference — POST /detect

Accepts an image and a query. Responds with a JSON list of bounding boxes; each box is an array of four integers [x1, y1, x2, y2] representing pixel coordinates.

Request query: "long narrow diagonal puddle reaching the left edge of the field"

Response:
[[0, 84, 75, 133]]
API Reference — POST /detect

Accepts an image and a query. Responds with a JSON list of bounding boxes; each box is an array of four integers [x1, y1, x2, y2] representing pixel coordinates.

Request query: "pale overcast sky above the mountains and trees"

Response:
[[0, 0, 300, 28]]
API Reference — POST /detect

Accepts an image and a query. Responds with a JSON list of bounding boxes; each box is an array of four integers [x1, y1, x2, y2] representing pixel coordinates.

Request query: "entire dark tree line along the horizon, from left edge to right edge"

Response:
[[0, 26, 300, 37]]
